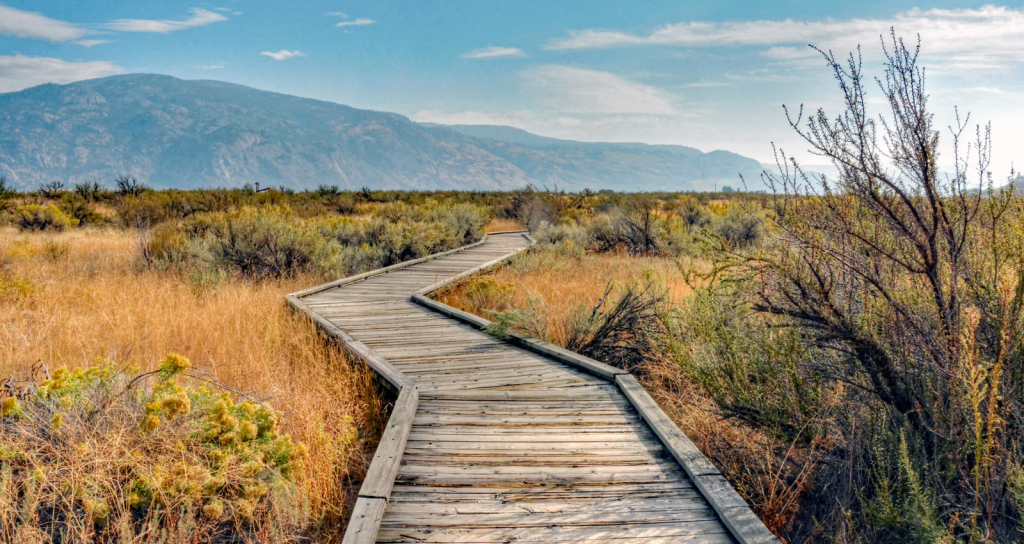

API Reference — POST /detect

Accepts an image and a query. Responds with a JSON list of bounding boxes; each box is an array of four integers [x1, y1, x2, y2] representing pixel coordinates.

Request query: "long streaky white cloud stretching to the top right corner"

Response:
[[546, 5, 1024, 68]]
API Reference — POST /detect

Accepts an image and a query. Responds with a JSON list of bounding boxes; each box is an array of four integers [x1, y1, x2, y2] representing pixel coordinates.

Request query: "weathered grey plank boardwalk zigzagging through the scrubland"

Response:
[[288, 233, 776, 544]]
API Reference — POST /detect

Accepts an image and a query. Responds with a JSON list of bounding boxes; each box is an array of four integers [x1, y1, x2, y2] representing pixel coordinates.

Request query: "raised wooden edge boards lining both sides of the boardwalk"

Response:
[[286, 231, 778, 544]]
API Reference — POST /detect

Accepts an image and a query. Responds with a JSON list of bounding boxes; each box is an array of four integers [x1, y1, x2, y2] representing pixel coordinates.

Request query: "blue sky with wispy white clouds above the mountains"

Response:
[[0, 0, 1024, 180]]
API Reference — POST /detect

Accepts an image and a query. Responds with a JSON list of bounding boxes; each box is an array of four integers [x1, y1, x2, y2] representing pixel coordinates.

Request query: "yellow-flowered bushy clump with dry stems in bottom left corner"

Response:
[[0, 353, 305, 542]]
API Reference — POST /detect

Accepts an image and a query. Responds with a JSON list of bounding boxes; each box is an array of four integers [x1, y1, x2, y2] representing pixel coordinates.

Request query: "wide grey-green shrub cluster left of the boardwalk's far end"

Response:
[[141, 202, 487, 278]]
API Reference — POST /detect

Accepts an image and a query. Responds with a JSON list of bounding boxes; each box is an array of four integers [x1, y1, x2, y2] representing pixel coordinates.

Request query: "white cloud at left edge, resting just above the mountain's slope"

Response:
[[0, 54, 124, 92]]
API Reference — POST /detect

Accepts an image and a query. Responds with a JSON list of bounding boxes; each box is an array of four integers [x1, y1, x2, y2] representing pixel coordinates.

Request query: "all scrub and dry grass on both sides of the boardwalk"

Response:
[[0, 38, 1024, 543]]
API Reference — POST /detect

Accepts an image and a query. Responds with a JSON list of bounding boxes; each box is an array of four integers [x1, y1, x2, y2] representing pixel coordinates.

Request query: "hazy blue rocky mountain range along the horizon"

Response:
[[0, 74, 760, 191]]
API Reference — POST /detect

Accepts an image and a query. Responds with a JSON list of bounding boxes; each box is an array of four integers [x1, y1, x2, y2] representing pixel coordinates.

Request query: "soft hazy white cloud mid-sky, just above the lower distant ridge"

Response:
[[522, 65, 677, 115]]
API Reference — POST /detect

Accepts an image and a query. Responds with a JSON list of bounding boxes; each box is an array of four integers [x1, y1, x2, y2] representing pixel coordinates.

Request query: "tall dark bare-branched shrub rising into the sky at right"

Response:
[[712, 35, 1024, 542]]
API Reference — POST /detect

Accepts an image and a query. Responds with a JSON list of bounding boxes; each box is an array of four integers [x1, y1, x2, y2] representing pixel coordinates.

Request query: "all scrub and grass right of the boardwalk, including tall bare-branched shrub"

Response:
[[439, 36, 1024, 543]]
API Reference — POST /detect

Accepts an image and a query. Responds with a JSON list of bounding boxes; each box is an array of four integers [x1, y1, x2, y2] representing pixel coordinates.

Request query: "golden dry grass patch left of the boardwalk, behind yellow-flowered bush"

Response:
[[0, 229, 382, 540]]
